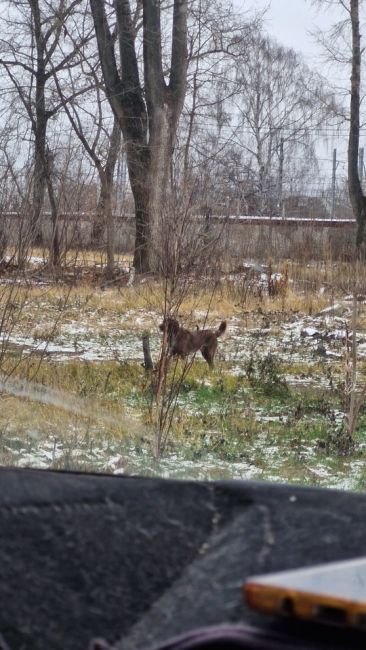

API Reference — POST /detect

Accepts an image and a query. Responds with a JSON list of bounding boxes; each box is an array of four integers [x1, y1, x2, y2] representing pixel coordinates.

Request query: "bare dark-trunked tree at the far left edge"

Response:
[[0, 0, 90, 265]]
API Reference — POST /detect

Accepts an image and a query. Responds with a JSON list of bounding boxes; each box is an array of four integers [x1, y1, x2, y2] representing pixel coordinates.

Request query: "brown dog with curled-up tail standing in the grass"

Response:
[[159, 318, 226, 367]]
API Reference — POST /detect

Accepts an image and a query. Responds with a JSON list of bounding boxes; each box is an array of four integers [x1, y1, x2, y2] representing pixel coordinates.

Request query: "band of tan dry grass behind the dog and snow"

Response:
[[0, 268, 344, 329]]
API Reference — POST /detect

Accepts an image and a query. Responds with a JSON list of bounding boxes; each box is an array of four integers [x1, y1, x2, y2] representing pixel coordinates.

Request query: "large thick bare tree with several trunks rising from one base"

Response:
[[90, 0, 188, 272]]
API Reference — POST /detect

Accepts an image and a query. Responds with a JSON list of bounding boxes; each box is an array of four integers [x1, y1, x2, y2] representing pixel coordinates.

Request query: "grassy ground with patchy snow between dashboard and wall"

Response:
[[0, 251, 366, 489]]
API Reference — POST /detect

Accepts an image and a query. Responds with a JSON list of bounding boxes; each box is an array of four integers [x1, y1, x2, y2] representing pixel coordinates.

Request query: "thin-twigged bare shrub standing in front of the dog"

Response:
[[150, 197, 224, 457]]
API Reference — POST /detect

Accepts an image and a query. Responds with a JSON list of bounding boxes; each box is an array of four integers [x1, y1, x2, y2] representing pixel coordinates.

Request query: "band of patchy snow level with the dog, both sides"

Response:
[[0, 294, 358, 383]]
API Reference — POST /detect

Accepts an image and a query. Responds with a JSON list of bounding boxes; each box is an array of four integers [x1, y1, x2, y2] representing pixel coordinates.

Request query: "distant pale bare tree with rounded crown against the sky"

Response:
[[234, 33, 334, 214]]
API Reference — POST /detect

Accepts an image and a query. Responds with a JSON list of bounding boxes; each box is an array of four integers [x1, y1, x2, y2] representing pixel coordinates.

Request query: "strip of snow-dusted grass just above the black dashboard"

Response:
[[3, 432, 366, 489]]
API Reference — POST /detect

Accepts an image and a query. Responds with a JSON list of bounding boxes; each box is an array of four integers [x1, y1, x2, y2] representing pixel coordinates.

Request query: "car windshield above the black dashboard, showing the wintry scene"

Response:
[[0, 0, 366, 489]]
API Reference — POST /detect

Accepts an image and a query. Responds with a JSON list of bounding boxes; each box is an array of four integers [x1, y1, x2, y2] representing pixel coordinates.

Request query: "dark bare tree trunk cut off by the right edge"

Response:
[[348, 0, 366, 255]]
